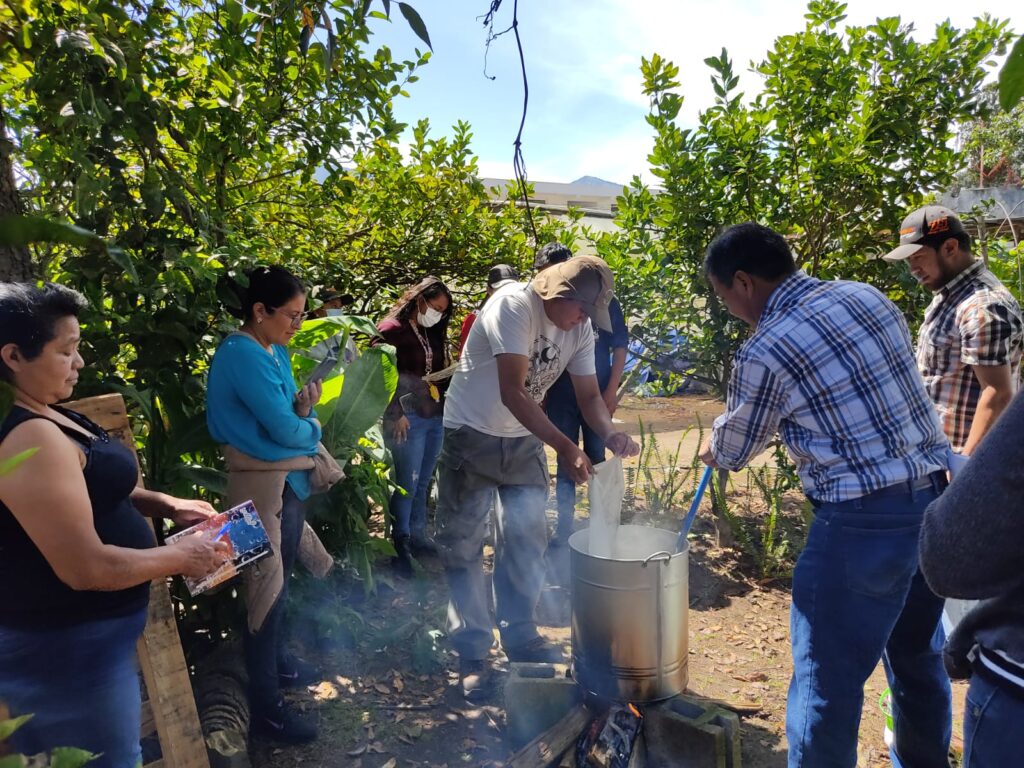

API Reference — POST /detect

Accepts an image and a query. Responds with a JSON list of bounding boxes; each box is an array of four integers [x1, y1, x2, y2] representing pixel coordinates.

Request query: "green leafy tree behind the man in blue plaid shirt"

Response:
[[596, 0, 1009, 391]]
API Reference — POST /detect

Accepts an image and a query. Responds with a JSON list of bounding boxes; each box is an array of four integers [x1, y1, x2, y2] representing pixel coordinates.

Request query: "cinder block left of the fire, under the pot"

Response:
[[505, 662, 581, 750]]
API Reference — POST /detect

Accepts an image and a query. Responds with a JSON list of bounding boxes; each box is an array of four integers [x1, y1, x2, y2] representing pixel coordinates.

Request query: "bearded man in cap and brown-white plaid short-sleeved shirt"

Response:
[[884, 206, 1024, 456]]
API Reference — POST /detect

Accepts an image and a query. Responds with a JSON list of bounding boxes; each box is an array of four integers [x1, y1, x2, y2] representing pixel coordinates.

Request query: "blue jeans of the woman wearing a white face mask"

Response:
[[384, 414, 444, 539]]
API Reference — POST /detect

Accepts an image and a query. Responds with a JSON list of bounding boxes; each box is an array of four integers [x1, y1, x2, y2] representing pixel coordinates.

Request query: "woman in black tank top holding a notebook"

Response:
[[0, 284, 226, 768]]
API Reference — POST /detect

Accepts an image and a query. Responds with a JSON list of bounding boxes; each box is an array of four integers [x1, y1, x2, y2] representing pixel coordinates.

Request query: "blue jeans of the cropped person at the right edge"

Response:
[[961, 673, 1024, 768]]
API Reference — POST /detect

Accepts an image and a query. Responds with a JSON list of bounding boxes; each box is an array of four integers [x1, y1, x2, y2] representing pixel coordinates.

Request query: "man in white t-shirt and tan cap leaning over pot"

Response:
[[436, 256, 638, 699]]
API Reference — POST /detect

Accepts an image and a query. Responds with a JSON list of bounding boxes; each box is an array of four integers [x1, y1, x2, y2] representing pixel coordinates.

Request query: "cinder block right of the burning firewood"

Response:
[[644, 695, 740, 768]]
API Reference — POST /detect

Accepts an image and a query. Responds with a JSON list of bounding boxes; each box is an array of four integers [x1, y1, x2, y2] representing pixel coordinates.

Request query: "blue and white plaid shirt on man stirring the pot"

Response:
[[711, 271, 949, 502]]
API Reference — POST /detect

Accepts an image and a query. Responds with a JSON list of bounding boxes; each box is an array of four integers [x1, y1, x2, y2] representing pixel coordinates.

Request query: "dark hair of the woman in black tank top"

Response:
[[0, 283, 89, 383]]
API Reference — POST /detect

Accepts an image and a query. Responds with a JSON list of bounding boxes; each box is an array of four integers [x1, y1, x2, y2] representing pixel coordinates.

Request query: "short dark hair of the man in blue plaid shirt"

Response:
[[705, 227, 797, 288]]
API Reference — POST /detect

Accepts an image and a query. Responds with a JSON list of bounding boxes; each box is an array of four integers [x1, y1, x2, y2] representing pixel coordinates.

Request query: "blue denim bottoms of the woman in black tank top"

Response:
[[0, 609, 146, 768]]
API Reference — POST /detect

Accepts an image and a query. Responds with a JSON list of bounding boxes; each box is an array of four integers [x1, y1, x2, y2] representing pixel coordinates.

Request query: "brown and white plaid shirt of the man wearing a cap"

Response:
[[918, 261, 1024, 452]]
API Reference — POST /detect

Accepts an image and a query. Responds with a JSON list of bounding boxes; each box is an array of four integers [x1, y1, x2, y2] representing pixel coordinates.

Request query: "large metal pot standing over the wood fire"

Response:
[[569, 525, 689, 702]]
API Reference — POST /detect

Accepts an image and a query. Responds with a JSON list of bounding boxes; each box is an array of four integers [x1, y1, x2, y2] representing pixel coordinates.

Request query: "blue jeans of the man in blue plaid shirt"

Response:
[[785, 480, 952, 768]]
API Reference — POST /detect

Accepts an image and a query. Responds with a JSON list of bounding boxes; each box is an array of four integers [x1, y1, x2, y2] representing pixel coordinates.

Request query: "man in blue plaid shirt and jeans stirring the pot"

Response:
[[701, 223, 952, 768]]
